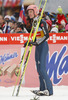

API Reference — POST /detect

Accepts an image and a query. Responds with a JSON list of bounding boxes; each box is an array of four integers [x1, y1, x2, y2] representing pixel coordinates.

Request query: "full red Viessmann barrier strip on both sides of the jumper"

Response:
[[0, 33, 68, 44]]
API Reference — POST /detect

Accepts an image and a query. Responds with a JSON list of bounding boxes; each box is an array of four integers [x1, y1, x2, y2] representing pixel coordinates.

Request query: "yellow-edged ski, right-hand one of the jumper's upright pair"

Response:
[[16, 0, 47, 96]]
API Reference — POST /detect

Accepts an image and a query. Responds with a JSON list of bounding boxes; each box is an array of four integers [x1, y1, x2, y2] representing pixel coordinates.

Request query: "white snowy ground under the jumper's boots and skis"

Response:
[[0, 86, 68, 100]]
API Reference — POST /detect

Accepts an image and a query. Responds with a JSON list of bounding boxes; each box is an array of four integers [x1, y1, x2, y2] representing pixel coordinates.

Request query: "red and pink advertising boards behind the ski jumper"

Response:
[[0, 33, 68, 87]]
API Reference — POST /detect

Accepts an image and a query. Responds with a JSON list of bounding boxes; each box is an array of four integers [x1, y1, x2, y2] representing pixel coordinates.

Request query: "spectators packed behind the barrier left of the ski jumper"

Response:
[[0, 15, 27, 34]]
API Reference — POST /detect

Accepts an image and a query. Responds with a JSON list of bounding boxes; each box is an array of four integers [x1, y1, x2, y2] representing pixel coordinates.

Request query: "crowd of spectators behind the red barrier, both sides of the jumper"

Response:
[[0, 6, 68, 34]]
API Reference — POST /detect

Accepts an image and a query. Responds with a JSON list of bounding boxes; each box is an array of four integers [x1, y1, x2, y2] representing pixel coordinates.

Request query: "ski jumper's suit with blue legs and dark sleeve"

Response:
[[35, 20, 53, 95]]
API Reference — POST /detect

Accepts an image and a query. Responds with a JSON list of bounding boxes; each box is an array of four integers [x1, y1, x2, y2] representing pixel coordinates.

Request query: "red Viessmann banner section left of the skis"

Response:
[[0, 34, 32, 44]]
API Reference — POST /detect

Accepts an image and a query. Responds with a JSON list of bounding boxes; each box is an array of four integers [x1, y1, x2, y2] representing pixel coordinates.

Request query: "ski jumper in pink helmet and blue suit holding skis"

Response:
[[24, 5, 53, 95]]
